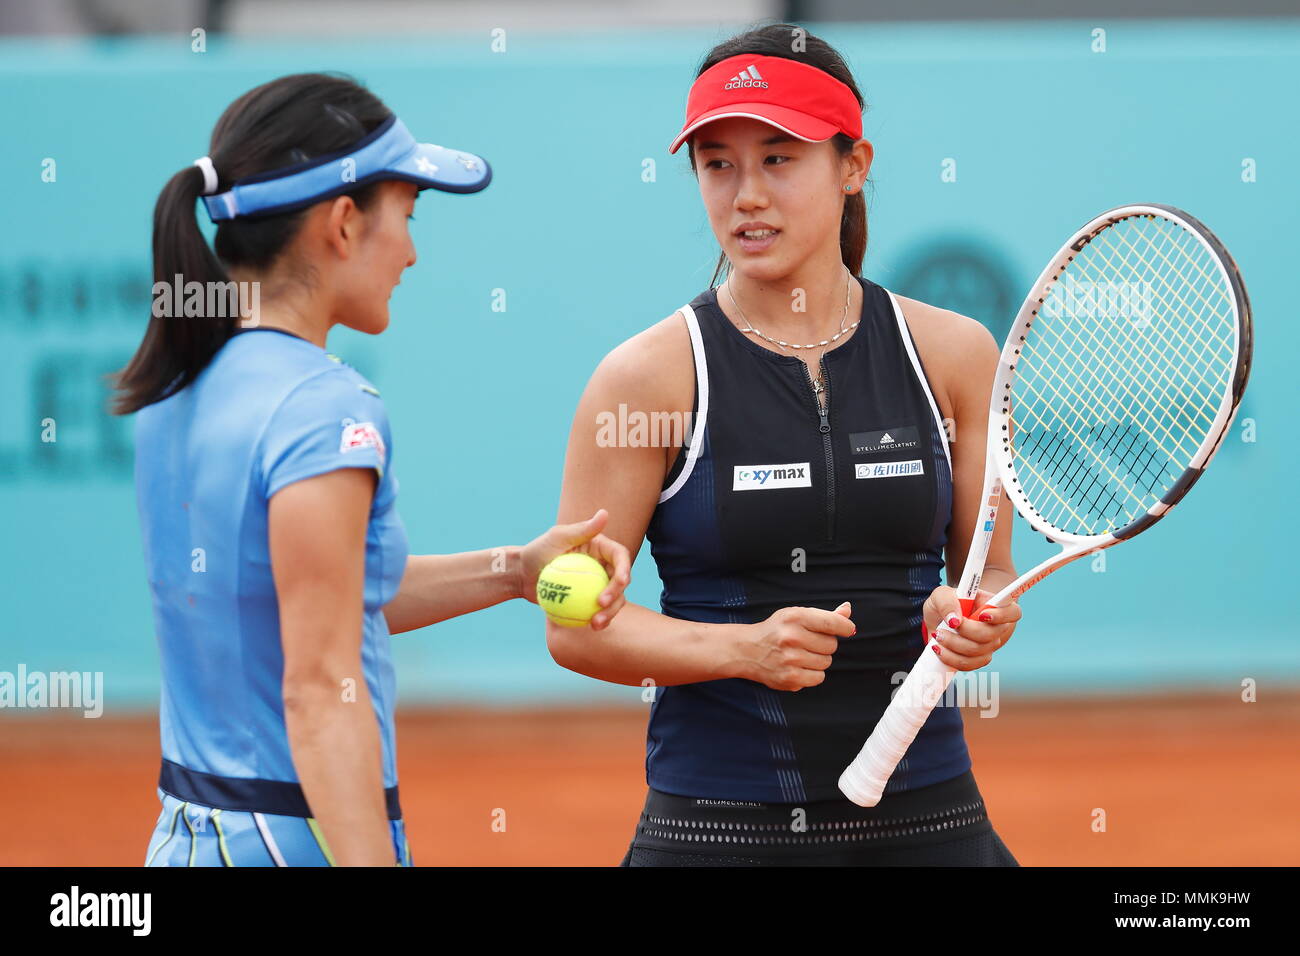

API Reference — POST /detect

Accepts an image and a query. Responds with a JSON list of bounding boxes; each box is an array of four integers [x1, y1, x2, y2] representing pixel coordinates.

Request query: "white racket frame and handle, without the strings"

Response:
[[840, 203, 1252, 806]]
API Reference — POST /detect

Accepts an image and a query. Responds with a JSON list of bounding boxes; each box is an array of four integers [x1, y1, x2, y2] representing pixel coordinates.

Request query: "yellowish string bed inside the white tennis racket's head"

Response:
[[1008, 216, 1236, 535]]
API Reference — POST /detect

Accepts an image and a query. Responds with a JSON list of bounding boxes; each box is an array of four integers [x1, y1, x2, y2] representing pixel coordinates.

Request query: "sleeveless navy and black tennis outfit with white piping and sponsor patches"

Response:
[[625, 278, 1010, 865]]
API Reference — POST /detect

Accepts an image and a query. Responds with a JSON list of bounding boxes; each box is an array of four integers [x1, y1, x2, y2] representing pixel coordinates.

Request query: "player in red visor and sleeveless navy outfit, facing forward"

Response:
[[549, 23, 1021, 866]]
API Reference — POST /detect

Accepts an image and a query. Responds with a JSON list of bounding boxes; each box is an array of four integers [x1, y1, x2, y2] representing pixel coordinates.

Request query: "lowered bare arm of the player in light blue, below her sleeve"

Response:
[[268, 468, 395, 866]]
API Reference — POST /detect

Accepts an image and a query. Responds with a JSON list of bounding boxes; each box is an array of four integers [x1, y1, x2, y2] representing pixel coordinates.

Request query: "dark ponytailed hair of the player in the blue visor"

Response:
[[112, 73, 391, 415]]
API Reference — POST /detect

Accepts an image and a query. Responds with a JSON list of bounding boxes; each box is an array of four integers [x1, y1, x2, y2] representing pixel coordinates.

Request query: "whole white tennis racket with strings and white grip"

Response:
[[840, 203, 1252, 806]]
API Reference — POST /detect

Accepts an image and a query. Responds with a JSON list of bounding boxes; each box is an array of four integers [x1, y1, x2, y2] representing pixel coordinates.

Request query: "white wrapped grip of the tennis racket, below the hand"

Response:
[[840, 634, 957, 806]]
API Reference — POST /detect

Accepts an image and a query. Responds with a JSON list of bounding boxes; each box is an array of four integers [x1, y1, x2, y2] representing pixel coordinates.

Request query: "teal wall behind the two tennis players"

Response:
[[0, 21, 1300, 710]]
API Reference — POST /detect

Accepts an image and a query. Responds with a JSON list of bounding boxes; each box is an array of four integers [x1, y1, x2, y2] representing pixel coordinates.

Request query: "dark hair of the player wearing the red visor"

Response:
[[688, 23, 867, 285]]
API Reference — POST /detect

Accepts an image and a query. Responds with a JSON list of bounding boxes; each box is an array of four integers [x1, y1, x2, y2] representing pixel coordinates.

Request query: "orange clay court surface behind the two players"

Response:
[[0, 688, 1300, 866]]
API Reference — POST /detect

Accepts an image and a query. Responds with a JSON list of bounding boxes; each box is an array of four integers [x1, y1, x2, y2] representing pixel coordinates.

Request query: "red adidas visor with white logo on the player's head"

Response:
[[668, 53, 862, 152]]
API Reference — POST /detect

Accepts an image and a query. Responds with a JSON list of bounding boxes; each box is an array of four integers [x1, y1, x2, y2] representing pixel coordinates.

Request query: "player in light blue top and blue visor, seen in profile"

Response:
[[116, 74, 629, 866]]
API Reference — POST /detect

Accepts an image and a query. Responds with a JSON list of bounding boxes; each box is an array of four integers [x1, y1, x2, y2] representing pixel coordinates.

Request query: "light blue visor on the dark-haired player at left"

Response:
[[203, 116, 491, 222]]
